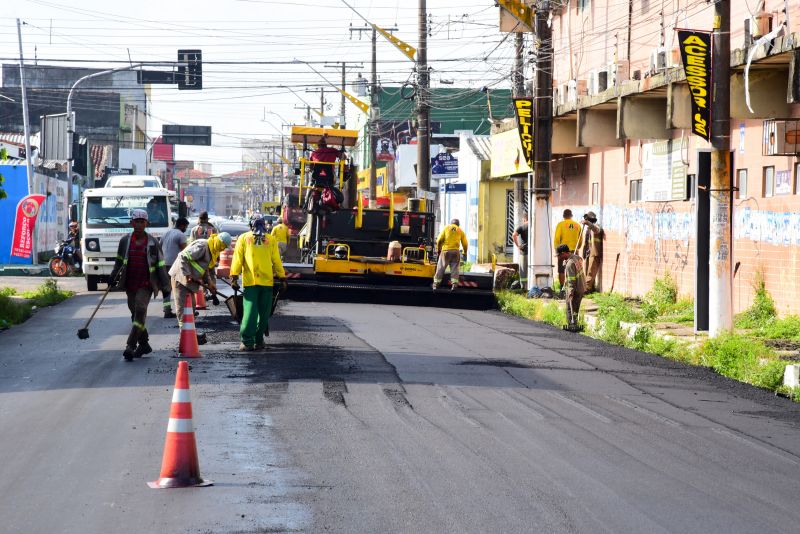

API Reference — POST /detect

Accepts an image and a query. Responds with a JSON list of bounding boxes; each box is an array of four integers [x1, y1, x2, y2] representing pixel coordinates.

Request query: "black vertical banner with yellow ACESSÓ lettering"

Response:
[[678, 30, 713, 141]]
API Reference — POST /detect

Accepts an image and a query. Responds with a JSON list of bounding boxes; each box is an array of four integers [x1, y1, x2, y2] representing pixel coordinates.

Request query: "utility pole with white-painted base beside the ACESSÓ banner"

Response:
[[708, 0, 733, 337]]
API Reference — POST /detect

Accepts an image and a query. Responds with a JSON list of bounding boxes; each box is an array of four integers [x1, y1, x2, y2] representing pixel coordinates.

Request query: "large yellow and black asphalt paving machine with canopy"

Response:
[[284, 127, 495, 309]]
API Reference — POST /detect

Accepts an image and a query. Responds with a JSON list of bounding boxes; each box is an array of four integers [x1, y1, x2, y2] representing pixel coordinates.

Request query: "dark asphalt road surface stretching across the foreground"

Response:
[[0, 293, 800, 534]]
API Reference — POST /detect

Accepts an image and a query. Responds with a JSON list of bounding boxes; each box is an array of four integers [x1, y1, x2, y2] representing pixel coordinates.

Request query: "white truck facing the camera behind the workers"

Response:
[[81, 186, 178, 291]]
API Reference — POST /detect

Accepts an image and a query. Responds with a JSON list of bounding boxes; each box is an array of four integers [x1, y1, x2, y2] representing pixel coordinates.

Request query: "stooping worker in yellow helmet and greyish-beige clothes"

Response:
[[169, 232, 231, 344]]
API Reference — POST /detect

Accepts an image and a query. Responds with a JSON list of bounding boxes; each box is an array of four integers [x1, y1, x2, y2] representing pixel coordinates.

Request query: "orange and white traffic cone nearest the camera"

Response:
[[147, 362, 212, 489]]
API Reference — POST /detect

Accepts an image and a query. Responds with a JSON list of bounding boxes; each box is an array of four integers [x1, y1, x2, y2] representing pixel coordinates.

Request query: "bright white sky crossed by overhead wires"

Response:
[[0, 0, 514, 173]]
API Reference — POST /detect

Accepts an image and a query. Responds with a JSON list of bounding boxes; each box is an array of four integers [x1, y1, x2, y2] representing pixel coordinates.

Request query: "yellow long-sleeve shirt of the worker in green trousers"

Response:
[[231, 232, 286, 287]]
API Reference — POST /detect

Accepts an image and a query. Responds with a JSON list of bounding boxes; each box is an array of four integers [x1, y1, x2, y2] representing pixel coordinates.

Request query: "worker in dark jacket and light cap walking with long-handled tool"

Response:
[[111, 209, 169, 362]]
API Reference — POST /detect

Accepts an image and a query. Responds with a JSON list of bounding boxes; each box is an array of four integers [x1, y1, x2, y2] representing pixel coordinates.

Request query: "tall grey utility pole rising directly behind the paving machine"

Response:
[[417, 0, 431, 198]]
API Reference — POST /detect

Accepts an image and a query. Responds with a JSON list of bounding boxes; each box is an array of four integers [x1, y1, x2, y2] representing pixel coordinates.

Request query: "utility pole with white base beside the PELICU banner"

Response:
[[528, 0, 553, 287]]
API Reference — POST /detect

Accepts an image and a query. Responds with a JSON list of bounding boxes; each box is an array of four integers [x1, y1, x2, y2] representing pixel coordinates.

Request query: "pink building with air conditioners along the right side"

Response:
[[536, 0, 800, 320]]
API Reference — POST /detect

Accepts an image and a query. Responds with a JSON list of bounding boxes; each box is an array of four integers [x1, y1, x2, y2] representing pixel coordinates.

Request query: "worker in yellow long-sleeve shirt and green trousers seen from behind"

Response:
[[231, 217, 286, 351]]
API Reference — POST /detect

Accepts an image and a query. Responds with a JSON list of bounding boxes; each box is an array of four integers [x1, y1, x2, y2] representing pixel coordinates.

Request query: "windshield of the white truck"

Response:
[[86, 195, 168, 228]]
